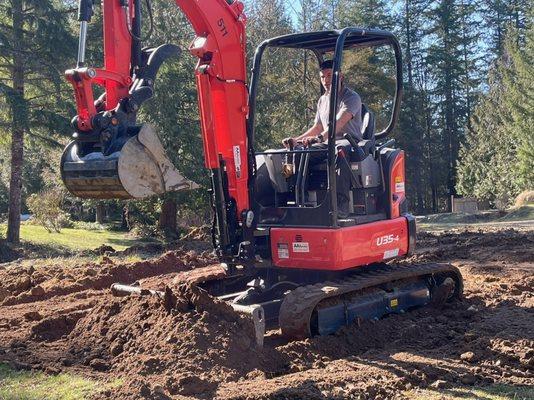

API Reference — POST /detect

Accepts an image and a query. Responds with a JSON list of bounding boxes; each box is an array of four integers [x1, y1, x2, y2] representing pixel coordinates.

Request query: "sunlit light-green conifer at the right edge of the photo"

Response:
[[458, 21, 534, 205]]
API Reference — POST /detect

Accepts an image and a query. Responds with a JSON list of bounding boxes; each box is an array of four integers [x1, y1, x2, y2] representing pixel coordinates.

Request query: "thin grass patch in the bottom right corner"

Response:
[[404, 385, 534, 400]]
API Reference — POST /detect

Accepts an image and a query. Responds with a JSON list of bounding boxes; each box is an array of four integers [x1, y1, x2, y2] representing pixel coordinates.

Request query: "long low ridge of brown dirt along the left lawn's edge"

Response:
[[0, 250, 213, 306]]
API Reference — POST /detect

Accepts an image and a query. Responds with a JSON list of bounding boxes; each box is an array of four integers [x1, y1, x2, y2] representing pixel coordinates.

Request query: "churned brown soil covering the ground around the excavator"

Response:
[[0, 230, 534, 399]]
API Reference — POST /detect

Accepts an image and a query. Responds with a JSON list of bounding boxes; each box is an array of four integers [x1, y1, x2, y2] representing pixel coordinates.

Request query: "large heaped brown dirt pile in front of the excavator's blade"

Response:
[[68, 285, 280, 399]]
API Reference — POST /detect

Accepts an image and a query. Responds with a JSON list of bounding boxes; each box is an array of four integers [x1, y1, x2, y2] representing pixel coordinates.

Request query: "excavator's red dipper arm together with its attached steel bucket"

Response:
[[60, 0, 196, 199]]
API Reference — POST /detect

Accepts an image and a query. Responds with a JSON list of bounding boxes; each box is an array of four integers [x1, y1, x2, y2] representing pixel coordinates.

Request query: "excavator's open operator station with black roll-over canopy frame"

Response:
[[249, 27, 406, 228]]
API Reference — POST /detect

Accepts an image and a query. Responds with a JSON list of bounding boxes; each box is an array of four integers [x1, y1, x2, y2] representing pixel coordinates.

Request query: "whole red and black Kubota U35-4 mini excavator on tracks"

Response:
[[61, 0, 463, 343]]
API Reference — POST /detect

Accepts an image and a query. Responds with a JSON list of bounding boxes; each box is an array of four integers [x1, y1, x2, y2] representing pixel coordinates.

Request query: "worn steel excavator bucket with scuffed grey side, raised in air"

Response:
[[61, 124, 198, 199]]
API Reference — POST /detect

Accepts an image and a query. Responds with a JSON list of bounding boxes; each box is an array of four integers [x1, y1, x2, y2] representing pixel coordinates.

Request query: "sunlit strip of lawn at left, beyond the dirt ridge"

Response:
[[2, 224, 157, 250]]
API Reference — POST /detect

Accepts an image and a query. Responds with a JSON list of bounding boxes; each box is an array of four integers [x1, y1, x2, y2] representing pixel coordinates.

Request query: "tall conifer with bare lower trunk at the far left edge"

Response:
[[0, 0, 75, 243]]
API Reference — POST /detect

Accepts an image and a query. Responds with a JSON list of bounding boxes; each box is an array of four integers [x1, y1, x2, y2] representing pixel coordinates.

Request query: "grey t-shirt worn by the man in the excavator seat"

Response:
[[315, 87, 363, 141]]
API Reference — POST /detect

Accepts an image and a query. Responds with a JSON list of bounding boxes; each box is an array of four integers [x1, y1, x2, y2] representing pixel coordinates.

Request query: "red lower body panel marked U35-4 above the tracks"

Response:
[[271, 217, 409, 271]]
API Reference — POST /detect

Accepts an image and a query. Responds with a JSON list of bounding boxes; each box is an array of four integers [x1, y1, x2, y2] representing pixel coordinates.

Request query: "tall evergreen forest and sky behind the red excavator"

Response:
[[0, 0, 534, 242]]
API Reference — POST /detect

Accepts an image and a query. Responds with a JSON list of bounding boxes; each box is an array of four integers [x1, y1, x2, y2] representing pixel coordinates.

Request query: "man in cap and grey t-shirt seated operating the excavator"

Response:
[[283, 60, 362, 218]]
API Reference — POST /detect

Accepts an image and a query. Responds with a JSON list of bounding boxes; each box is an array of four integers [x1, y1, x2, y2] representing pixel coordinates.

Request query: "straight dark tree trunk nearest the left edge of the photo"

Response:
[[6, 0, 25, 243]]
